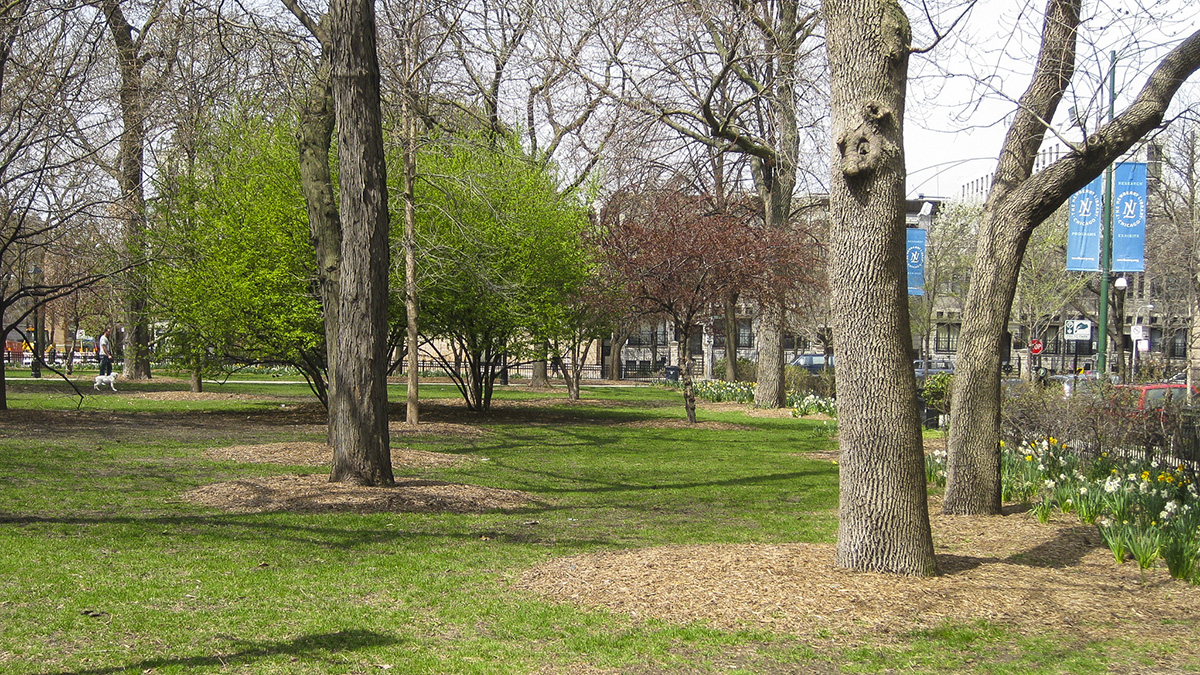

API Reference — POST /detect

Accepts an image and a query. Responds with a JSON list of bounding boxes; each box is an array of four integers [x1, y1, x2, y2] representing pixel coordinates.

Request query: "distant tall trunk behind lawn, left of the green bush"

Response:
[[103, 0, 150, 380]]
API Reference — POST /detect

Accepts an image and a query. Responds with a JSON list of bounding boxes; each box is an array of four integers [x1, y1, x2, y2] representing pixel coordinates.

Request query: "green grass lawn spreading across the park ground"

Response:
[[0, 381, 1195, 675]]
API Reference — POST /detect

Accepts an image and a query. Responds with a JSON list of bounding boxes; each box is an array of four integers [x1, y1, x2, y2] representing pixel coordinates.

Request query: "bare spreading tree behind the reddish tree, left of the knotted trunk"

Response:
[[593, 0, 824, 407]]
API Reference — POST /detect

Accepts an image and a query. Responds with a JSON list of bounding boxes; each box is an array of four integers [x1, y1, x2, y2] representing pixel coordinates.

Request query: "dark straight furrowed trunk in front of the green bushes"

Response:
[[329, 0, 394, 485]]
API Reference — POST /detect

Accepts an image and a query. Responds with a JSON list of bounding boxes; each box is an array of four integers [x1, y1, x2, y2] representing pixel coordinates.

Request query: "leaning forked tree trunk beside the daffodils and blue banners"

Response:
[[945, 0, 1200, 515]]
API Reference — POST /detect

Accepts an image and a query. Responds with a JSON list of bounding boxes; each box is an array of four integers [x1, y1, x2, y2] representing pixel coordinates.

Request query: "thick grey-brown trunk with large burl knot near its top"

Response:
[[823, 0, 936, 575]]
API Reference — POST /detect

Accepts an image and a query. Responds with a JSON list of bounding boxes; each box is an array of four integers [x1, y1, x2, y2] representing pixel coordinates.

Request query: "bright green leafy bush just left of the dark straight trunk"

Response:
[[151, 110, 323, 379]]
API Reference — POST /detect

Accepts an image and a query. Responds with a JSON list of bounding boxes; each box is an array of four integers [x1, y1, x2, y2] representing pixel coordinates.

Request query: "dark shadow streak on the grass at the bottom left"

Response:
[[38, 629, 400, 675]]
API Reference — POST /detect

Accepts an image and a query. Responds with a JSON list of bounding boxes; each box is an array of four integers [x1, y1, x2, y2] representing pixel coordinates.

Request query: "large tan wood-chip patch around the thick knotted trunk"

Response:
[[518, 502, 1200, 659]]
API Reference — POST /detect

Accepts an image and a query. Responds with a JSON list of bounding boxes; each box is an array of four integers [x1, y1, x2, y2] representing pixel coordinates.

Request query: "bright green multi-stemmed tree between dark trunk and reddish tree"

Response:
[[416, 138, 587, 411]]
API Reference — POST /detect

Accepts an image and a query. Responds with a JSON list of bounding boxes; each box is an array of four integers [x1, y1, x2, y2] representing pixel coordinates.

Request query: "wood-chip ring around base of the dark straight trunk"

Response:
[[184, 473, 535, 513]]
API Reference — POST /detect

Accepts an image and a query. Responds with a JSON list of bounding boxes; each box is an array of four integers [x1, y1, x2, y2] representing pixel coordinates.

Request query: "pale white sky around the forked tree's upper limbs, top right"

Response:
[[905, 0, 1200, 198]]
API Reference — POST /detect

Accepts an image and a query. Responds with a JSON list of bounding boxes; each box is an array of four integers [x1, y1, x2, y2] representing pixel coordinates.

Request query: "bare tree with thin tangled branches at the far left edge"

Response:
[[0, 0, 120, 408]]
